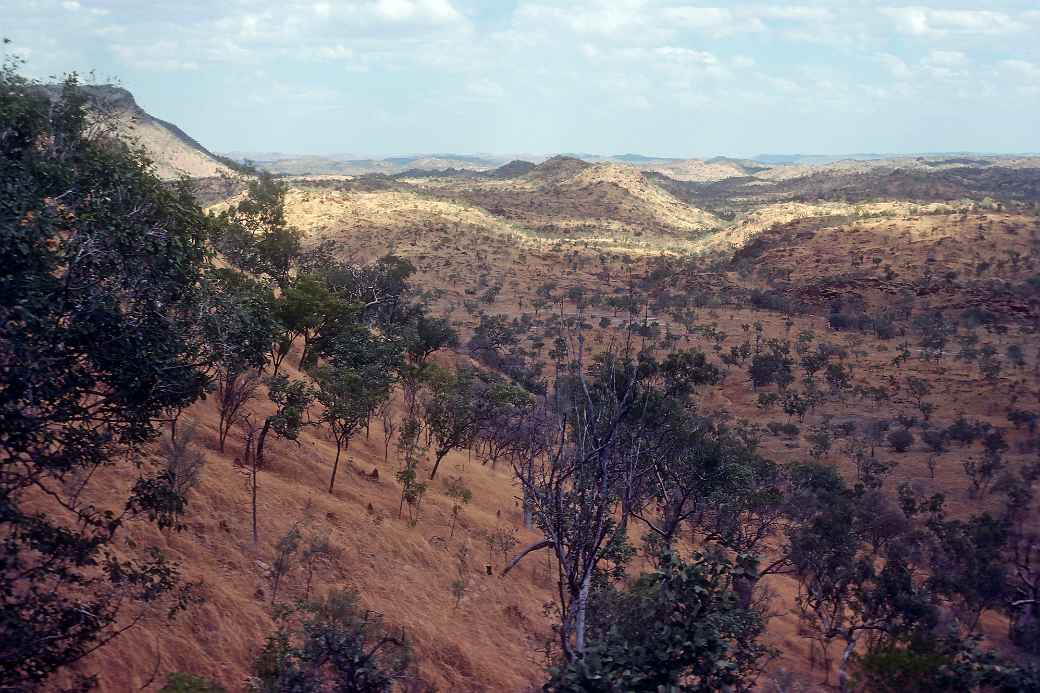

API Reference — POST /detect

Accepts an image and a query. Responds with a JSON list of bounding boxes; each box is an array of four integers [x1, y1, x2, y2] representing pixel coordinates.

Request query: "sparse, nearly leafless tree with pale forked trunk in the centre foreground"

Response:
[[503, 340, 661, 662]]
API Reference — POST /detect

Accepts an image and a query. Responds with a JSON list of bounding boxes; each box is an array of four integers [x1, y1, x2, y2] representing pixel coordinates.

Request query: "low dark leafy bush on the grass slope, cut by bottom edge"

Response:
[[249, 591, 412, 693]]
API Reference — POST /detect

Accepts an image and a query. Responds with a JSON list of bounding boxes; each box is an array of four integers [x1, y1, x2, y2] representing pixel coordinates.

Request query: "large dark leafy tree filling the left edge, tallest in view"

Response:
[[0, 68, 207, 691]]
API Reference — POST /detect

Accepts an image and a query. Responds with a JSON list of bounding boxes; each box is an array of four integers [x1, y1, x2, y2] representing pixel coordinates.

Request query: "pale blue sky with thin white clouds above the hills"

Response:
[[0, 0, 1040, 157]]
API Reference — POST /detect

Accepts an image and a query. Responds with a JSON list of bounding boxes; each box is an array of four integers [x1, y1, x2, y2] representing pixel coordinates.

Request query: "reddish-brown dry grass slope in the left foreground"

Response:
[[76, 353, 552, 691]]
